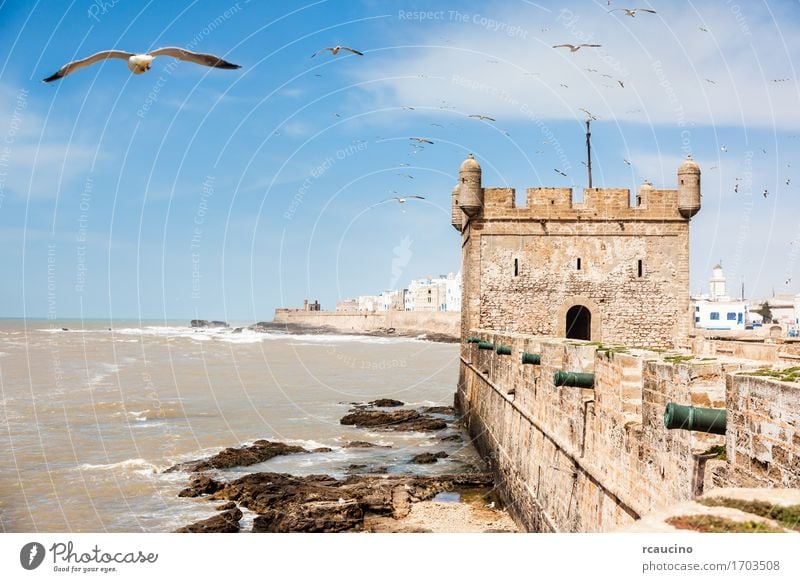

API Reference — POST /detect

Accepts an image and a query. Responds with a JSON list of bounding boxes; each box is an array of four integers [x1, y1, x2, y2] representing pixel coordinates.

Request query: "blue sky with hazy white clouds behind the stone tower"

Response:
[[0, 0, 800, 321]]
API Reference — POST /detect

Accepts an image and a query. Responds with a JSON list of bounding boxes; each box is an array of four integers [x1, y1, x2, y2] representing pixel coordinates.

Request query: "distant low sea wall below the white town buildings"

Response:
[[273, 309, 461, 339]]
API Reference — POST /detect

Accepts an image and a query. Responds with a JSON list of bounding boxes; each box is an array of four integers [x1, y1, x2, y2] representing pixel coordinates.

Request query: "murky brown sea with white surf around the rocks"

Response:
[[0, 319, 482, 533]]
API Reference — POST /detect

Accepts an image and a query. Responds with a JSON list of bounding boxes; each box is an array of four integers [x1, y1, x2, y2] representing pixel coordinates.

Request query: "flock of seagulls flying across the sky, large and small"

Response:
[[43, 5, 791, 207]]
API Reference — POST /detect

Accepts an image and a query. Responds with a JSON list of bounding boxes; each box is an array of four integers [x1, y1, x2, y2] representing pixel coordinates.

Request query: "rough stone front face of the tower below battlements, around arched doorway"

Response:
[[478, 223, 690, 347]]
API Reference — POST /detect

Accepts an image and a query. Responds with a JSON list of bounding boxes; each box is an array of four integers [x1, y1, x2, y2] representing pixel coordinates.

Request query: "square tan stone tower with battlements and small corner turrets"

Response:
[[452, 154, 700, 347]]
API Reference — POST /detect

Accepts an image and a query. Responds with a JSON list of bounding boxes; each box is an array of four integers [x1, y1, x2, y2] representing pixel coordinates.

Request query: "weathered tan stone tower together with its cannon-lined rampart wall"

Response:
[[452, 156, 800, 532]]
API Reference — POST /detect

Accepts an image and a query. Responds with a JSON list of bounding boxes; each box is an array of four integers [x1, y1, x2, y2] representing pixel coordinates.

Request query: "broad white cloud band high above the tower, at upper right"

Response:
[[359, 3, 800, 128]]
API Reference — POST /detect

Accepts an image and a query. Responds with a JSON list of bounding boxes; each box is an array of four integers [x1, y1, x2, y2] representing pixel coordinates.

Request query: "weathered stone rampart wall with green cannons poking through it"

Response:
[[456, 330, 780, 532]]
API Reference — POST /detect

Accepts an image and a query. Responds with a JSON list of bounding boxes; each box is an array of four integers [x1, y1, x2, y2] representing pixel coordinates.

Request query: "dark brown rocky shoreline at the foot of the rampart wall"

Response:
[[171, 399, 518, 533]]
